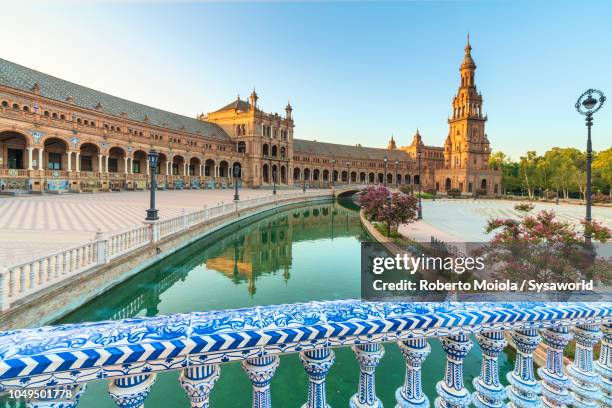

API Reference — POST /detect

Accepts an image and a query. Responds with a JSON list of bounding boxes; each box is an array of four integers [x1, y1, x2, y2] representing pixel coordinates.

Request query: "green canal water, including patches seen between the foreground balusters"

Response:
[[57, 201, 512, 408]]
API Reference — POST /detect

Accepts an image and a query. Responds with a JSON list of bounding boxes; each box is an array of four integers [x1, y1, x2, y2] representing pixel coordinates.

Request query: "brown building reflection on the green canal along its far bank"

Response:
[[55, 201, 365, 323]]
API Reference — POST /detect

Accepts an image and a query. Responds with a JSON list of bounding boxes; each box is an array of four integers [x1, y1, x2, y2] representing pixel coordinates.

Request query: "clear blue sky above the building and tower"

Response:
[[0, 0, 612, 158]]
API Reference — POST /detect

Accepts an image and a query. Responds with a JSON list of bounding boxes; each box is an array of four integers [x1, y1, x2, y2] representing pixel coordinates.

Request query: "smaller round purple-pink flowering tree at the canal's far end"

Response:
[[359, 187, 418, 236]]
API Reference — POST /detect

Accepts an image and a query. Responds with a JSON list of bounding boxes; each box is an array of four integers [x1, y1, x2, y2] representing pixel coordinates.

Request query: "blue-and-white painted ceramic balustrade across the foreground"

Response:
[[0, 301, 612, 408]]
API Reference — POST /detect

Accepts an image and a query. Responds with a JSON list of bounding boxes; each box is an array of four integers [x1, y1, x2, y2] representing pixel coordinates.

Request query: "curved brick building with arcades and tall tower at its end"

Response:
[[0, 43, 501, 194]]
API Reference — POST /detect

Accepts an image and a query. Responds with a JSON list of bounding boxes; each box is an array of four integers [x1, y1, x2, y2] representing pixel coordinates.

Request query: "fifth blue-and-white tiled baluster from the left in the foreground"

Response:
[[300, 348, 335, 408]]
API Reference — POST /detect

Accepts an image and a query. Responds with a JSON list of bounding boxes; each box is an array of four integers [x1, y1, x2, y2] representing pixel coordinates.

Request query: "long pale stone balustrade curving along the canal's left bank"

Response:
[[0, 191, 330, 311]]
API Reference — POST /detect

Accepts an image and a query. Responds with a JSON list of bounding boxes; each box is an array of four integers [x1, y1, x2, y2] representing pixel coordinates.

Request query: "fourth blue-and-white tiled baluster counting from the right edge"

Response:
[[506, 329, 541, 408]]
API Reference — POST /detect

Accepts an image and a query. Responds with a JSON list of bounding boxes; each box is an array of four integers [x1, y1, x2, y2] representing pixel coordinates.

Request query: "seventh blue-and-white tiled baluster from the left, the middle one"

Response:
[[395, 339, 431, 408]]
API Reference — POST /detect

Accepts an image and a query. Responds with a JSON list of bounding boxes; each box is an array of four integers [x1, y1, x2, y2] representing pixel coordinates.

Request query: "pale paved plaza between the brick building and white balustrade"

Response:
[[0, 189, 310, 265]]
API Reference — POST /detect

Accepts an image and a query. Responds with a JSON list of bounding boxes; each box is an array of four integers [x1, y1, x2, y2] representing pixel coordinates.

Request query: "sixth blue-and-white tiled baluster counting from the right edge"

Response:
[[435, 334, 472, 408]]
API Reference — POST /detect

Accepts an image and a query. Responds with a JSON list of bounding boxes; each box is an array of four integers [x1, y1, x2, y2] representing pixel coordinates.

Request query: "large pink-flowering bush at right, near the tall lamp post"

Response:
[[484, 204, 612, 290]]
